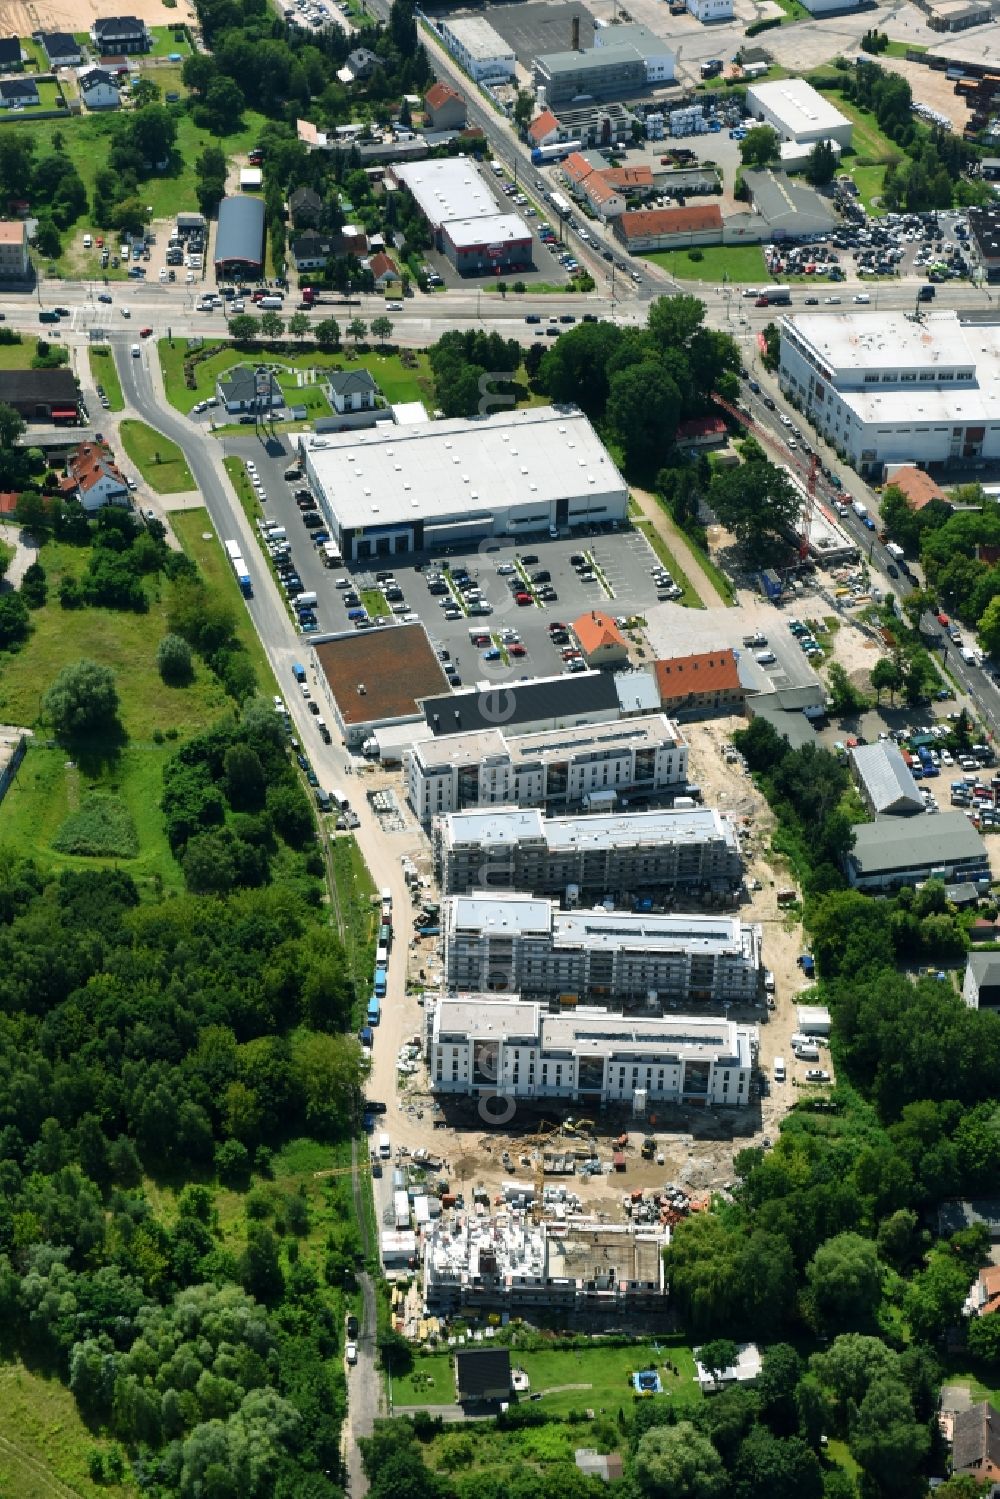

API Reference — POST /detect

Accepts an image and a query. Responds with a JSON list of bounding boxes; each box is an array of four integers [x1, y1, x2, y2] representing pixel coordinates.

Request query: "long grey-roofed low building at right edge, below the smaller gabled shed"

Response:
[[847, 812, 991, 892]]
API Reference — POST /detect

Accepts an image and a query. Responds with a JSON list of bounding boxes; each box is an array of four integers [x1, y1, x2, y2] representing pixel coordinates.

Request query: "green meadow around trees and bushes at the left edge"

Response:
[[0, 539, 233, 887]]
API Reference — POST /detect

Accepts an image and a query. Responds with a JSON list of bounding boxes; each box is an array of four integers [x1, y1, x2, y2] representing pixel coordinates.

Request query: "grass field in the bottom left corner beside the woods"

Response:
[[0, 1363, 139, 1499]]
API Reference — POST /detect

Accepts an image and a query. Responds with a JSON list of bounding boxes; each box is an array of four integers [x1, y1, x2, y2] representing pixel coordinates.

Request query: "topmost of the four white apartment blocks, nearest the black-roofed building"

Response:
[[403, 714, 688, 823]]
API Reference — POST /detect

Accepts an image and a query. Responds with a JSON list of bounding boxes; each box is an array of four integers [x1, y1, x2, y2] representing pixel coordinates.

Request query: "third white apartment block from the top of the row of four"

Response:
[[442, 892, 763, 1012]]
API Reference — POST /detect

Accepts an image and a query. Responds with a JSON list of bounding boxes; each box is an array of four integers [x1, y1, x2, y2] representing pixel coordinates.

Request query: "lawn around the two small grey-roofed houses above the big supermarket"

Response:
[[157, 337, 433, 414]]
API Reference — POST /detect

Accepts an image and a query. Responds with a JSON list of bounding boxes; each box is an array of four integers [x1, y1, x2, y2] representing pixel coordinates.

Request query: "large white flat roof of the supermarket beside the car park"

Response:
[[301, 406, 625, 528]]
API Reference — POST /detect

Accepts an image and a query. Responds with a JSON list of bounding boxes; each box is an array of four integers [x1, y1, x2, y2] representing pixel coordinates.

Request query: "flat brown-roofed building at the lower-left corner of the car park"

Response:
[[310, 624, 447, 748]]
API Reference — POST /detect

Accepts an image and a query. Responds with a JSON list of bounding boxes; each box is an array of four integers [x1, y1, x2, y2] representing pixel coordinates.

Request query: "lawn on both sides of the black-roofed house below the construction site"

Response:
[[393, 1342, 702, 1415]]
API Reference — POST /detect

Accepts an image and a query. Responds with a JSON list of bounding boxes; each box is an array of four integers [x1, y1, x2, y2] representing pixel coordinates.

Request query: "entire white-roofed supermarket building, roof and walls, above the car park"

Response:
[[296, 404, 628, 561]]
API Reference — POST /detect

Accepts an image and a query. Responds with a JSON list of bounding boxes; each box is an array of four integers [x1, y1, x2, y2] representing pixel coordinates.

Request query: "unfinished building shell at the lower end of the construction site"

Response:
[[423, 1208, 670, 1319]]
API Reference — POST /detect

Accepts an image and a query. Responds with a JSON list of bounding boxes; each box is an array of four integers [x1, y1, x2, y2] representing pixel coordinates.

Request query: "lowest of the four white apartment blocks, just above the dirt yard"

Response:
[[429, 994, 759, 1112]]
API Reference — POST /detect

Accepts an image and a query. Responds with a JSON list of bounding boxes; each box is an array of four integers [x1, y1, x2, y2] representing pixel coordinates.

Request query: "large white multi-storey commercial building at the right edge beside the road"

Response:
[[780, 312, 1000, 477]]
